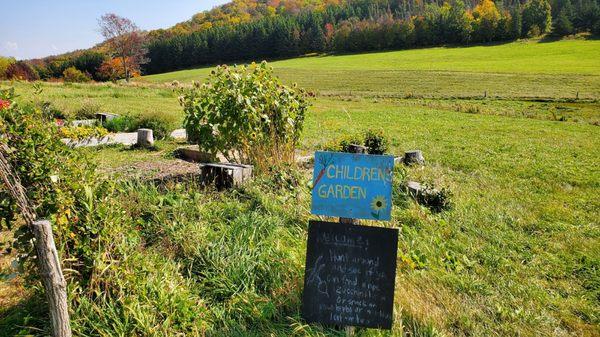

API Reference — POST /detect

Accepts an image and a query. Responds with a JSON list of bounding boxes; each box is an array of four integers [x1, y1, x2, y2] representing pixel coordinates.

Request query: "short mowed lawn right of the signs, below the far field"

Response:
[[303, 100, 600, 336]]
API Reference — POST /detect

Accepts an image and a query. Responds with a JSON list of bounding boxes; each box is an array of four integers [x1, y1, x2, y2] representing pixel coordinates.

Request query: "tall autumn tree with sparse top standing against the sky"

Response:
[[98, 13, 147, 82]]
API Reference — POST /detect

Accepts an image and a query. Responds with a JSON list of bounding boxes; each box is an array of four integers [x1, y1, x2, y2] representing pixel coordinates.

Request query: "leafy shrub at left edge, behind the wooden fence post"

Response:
[[0, 90, 94, 266]]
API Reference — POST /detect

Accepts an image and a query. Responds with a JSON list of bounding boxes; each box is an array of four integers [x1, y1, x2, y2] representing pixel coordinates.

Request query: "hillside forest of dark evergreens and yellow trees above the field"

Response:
[[145, 0, 600, 73]]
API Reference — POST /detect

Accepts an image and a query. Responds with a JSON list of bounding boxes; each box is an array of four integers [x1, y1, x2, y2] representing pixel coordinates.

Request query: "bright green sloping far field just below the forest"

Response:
[[140, 40, 600, 99]]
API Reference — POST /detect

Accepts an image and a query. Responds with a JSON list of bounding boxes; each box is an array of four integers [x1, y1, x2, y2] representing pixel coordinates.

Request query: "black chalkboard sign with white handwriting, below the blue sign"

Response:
[[302, 221, 398, 329]]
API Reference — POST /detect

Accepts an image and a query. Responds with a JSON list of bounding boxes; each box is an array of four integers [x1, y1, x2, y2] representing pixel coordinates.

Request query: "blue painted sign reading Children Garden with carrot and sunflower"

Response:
[[311, 152, 394, 221]]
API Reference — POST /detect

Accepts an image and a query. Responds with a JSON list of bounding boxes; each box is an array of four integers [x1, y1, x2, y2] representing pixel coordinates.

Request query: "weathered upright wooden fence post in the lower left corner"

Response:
[[32, 220, 71, 337]]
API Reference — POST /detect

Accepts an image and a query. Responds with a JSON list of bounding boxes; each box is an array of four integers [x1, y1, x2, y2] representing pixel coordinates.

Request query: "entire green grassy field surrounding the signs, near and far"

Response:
[[0, 40, 600, 336]]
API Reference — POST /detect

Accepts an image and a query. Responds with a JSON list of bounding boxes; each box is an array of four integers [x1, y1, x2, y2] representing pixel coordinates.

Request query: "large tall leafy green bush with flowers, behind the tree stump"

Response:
[[180, 62, 308, 171]]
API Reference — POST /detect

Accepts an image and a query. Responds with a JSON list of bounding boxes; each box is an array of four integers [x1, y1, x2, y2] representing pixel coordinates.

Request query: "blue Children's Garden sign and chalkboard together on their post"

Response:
[[302, 146, 398, 336]]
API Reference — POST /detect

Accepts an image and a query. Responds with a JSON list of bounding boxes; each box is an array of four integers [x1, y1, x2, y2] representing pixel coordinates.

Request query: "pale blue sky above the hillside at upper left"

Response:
[[0, 0, 228, 59]]
